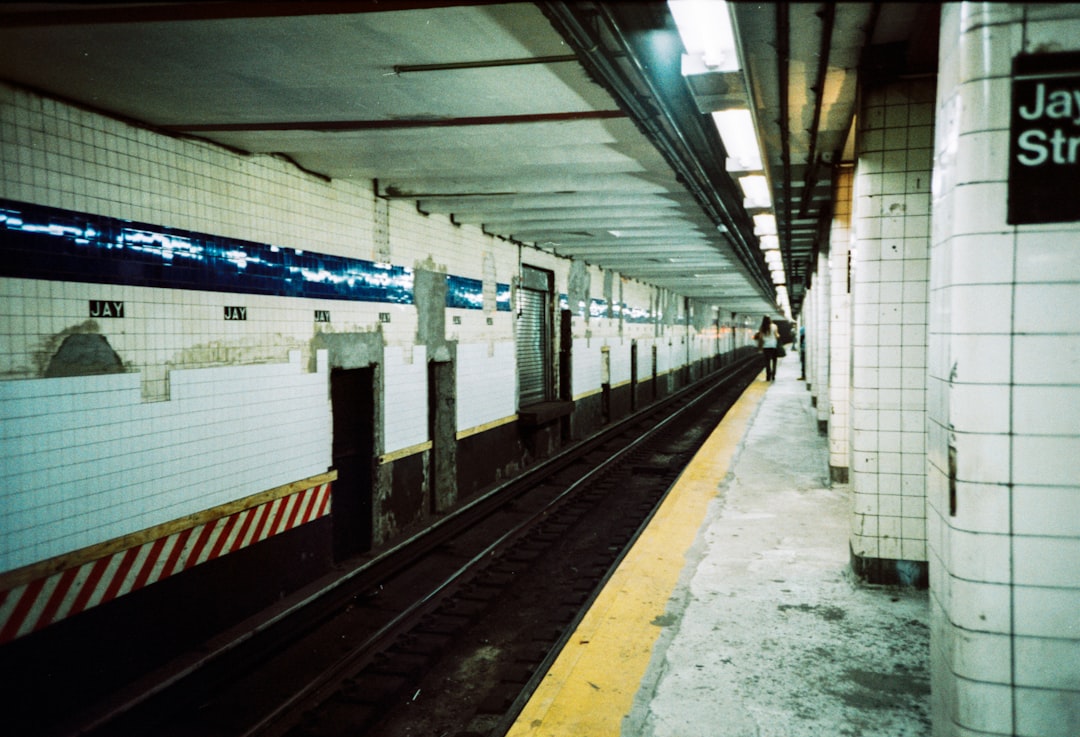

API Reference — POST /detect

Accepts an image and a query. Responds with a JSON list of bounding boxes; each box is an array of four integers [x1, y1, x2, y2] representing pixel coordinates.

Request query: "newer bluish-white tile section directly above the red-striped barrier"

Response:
[[0, 351, 330, 571]]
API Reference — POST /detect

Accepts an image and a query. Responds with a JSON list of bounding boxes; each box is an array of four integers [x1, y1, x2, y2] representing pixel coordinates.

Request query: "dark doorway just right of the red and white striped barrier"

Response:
[[330, 367, 375, 560]]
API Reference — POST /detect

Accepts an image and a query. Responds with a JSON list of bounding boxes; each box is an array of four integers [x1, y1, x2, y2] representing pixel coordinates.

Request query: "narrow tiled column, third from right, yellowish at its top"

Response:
[[828, 166, 853, 483]]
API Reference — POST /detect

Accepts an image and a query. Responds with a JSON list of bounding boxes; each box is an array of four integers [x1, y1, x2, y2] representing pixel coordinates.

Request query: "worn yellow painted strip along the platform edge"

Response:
[[507, 381, 769, 737]]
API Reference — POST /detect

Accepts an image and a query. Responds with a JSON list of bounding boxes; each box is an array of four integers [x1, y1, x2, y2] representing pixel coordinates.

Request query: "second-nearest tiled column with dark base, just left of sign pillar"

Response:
[[851, 79, 934, 585]]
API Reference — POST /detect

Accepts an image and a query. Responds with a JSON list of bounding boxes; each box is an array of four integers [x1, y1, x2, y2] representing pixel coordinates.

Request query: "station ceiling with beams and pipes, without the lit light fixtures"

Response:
[[0, 1, 936, 314]]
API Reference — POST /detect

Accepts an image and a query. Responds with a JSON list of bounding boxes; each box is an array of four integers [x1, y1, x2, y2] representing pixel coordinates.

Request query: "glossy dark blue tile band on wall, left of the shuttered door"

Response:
[[0, 200, 510, 311]]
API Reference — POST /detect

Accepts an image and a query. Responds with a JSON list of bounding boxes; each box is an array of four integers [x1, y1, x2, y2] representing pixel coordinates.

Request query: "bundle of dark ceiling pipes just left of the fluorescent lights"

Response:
[[539, 2, 775, 298]]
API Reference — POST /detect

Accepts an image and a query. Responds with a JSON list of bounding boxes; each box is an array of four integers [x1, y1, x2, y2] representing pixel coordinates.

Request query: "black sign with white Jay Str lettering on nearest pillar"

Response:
[[1008, 53, 1080, 225]]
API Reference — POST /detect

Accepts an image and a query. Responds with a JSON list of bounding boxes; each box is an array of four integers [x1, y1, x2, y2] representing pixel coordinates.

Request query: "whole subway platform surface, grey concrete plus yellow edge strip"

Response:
[[508, 352, 930, 737]]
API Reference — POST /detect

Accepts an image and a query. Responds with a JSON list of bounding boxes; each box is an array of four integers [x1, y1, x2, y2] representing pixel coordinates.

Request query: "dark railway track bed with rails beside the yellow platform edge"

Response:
[[61, 358, 759, 737]]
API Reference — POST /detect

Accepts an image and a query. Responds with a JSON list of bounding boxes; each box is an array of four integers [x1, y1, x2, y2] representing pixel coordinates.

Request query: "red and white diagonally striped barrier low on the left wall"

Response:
[[0, 482, 330, 644]]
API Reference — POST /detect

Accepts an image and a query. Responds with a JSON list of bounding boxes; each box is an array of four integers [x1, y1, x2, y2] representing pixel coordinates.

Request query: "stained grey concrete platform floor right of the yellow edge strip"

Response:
[[622, 352, 930, 737]]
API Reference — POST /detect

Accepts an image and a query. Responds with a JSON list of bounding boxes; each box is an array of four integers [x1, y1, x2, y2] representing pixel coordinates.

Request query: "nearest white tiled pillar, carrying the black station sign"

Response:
[[928, 2, 1080, 737]]
